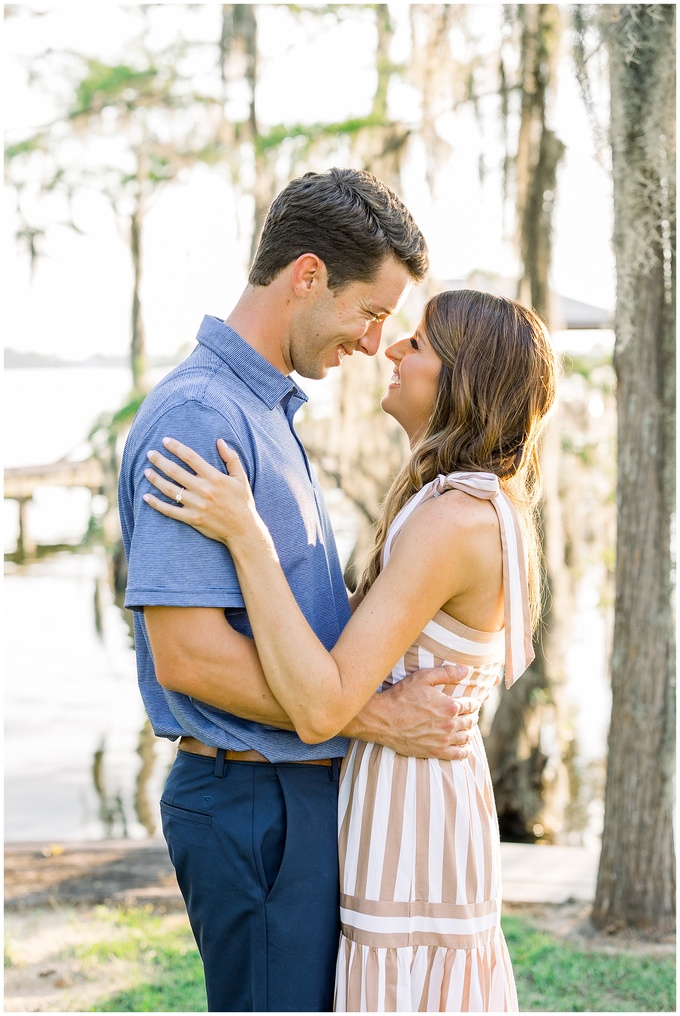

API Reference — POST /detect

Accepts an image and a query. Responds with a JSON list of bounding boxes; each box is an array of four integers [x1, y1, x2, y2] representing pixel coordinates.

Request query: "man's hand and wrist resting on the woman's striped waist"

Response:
[[343, 664, 480, 759]]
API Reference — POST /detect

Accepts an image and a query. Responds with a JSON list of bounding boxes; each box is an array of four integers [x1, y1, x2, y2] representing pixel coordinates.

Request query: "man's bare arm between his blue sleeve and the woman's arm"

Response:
[[144, 607, 294, 731]]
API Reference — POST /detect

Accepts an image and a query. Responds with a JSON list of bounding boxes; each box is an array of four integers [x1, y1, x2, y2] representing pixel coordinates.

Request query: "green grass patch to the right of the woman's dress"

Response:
[[503, 916, 675, 1013]]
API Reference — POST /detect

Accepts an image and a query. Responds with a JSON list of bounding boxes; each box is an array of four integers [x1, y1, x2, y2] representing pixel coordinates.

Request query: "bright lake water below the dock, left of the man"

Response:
[[4, 554, 174, 841]]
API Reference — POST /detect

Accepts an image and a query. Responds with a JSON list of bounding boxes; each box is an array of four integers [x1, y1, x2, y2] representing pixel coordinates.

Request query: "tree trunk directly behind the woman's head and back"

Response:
[[485, 4, 569, 842]]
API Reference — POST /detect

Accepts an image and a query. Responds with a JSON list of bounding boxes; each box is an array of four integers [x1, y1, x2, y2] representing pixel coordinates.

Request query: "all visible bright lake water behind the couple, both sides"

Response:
[[4, 368, 610, 842]]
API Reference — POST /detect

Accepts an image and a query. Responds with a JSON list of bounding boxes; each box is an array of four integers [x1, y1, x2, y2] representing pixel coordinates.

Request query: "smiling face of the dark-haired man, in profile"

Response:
[[290, 256, 412, 379]]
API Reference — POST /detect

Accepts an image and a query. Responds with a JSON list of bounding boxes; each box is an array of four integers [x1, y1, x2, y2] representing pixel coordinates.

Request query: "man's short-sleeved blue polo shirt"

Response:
[[119, 317, 350, 762]]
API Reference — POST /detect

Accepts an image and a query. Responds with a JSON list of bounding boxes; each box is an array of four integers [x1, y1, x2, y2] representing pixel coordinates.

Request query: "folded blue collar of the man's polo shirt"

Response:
[[196, 314, 308, 409]]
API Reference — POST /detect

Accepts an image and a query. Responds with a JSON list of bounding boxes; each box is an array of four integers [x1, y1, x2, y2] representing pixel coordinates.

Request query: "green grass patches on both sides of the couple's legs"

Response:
[[76, 908, 675, 1012]]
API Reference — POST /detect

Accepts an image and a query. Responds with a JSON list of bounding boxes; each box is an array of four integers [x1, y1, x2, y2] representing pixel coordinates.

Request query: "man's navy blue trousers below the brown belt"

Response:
[[161, 751, 339, 1012]]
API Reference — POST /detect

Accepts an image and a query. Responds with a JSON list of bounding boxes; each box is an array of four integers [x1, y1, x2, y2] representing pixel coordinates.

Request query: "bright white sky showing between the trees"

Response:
[[5, 3, 614, 359]]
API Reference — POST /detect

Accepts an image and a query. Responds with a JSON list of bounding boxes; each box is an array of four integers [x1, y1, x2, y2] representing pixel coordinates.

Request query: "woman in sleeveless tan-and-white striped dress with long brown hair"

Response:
[[145, 291, 556, 1012]]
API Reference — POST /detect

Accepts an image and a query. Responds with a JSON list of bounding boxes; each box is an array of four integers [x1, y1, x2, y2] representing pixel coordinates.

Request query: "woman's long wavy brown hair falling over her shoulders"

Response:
[[360, 290, 557, 625]]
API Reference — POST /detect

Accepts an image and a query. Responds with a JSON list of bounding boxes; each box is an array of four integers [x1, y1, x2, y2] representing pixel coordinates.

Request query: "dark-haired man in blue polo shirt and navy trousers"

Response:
[[120, 170, 476, 1012]]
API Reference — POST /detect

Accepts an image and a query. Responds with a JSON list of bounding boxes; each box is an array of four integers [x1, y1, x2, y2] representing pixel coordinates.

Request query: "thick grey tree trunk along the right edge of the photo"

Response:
[[593, 4, 675, 934]]
